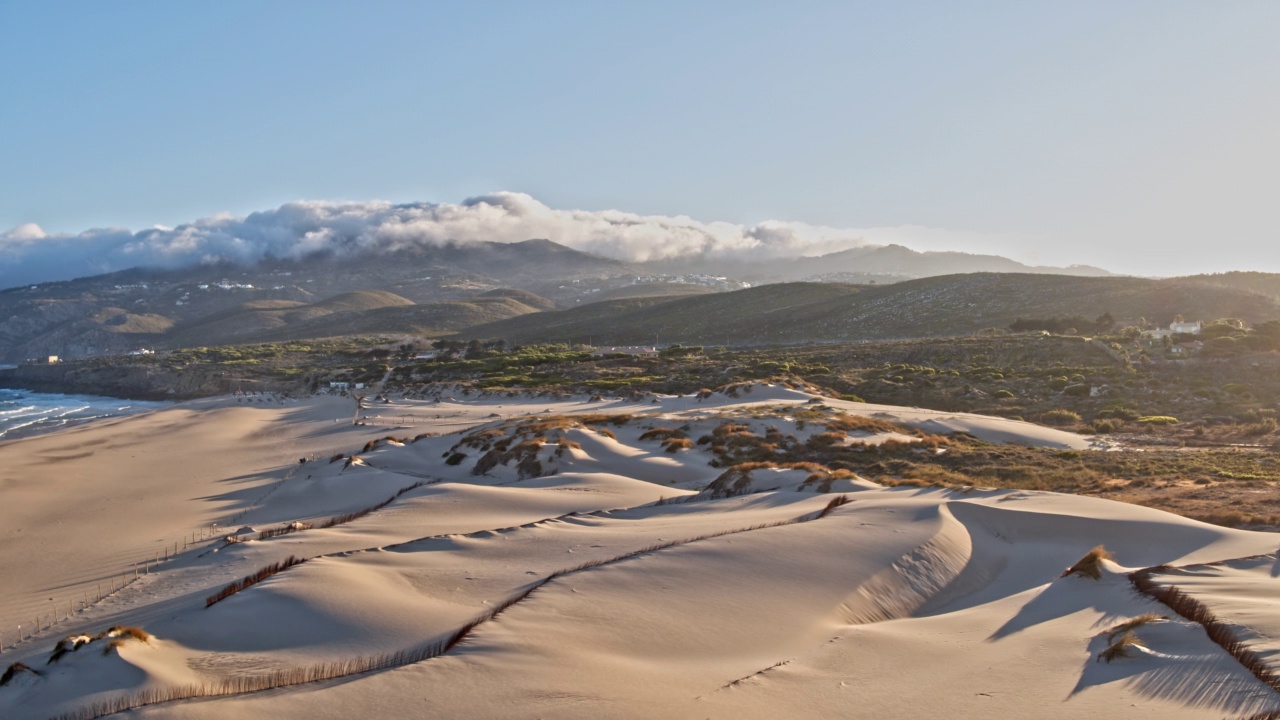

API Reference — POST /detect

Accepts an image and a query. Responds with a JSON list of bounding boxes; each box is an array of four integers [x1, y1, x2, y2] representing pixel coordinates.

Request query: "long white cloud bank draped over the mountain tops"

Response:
[[0, 192, 998, 287]]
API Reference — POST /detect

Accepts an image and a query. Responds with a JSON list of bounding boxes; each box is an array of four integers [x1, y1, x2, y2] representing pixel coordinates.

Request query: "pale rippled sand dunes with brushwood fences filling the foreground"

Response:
[[0, 386, 1280, 719]]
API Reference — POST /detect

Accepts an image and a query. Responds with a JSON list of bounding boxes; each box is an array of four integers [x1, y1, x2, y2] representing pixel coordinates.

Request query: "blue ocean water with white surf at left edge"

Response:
[[0, 388, 173, 439]]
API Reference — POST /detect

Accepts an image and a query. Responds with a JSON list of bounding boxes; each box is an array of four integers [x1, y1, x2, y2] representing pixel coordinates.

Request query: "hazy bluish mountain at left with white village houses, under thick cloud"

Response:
[[0, 240, 637, 363]]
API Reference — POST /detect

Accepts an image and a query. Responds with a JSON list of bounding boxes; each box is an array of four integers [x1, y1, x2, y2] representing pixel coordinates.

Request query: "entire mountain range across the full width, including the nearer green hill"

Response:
[[0, 234, 1280, 363]]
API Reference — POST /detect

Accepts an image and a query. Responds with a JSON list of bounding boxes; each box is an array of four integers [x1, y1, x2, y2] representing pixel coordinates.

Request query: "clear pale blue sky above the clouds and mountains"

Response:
[[0, 0, 1280, 278]]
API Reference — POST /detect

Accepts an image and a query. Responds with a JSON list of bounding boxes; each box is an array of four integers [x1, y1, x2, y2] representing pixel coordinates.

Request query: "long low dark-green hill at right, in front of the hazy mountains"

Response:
[[460, 273, 1280, 345]]
